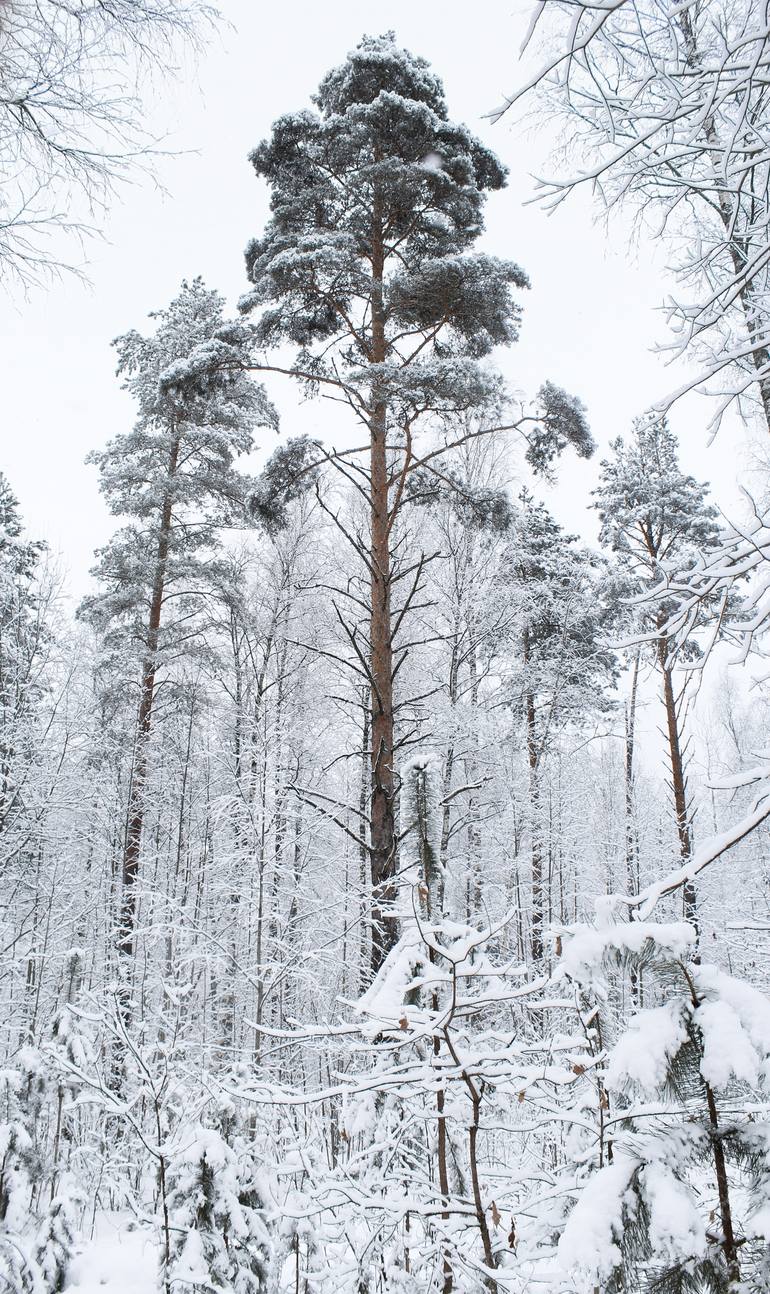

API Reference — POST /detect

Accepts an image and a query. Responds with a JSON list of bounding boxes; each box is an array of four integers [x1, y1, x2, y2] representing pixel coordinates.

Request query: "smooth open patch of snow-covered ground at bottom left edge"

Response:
[[66, 1215, 158, 1294]]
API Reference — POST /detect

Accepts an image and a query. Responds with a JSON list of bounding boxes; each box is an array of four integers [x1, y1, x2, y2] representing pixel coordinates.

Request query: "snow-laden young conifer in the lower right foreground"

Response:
[[559, 923, 770, 1291]]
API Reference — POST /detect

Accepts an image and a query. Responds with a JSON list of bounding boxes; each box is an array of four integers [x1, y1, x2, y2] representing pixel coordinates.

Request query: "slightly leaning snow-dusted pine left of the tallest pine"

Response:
[[80, 280, 274, 973]]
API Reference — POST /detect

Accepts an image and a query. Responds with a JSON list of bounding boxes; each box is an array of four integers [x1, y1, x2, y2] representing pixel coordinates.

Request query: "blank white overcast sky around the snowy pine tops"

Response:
[[0, 0, 760, 597]]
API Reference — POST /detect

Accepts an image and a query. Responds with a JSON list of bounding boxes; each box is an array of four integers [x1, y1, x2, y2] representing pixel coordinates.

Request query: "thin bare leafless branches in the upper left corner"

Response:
[[0, 0, 216, 286]]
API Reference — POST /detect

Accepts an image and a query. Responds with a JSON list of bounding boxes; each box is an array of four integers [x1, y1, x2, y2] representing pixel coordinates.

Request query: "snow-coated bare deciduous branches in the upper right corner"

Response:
[[494, 0, 770, 428]]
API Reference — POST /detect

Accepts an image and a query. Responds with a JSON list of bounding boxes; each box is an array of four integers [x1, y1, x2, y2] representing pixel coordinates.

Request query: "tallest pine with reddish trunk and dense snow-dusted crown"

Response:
[[242, 32, 590, 967]]
